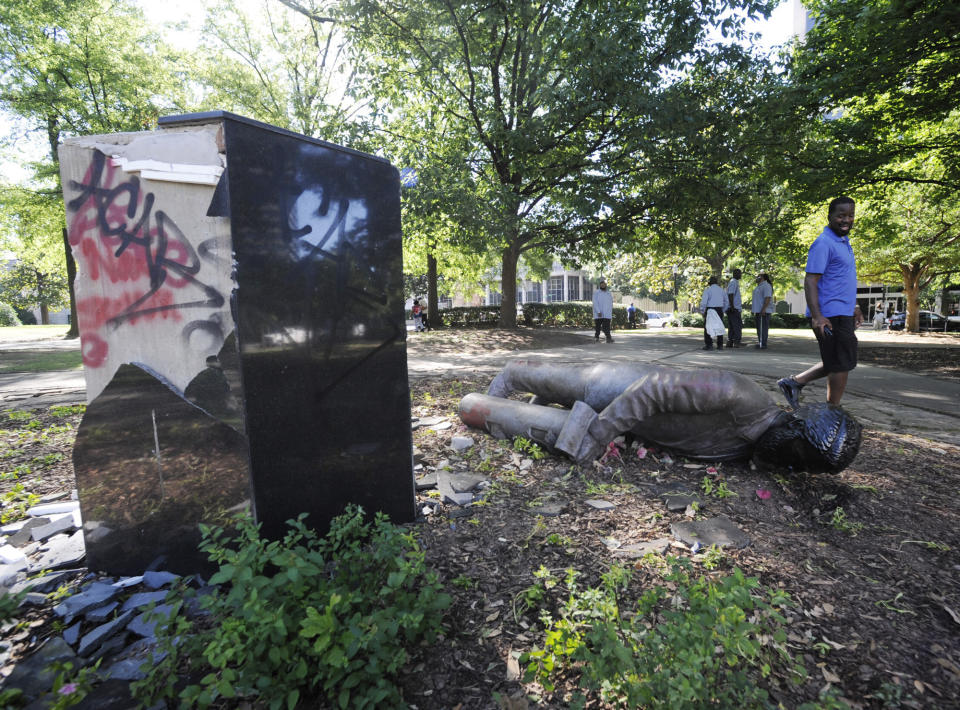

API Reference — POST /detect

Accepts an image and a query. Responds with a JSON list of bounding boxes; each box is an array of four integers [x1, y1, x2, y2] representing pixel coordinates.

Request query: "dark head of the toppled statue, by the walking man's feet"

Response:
[[754, 402, 863, 473]]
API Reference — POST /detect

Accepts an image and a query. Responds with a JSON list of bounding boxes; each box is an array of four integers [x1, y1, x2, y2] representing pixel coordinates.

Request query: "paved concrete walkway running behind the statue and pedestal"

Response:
[[0, 330, 960, 446]]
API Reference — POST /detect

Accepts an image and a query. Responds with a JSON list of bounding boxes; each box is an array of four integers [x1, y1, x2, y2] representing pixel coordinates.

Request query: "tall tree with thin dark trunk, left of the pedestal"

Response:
[[0, 0, 185, 337]]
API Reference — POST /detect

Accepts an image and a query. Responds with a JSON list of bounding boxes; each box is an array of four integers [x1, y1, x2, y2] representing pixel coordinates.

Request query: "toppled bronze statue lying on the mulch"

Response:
[[460, 361, 863, 473]]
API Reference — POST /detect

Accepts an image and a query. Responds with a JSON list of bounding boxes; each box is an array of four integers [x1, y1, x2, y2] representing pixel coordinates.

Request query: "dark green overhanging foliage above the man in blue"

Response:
[[778, 0, 960, 202]]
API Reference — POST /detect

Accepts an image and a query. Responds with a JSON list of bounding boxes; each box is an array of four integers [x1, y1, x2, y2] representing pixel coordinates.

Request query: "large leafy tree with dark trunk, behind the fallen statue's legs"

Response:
[[347, 0, 770, 327]]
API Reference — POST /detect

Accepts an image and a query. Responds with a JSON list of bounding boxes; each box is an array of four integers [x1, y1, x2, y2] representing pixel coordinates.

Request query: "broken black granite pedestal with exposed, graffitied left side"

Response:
[[61, 112, 414, 573]]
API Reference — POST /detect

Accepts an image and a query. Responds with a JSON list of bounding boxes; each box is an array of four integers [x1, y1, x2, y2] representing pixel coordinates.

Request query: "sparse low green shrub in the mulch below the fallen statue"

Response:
[[521, 558, 806, 710]]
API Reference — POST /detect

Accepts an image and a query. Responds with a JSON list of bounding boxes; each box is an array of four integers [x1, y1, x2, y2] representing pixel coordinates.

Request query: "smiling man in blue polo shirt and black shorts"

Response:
[[777, 197, 863, 409]]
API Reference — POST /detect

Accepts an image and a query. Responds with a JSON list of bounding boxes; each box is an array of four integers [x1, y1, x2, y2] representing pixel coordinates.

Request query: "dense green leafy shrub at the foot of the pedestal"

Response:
[[133, 507, 450, 710]]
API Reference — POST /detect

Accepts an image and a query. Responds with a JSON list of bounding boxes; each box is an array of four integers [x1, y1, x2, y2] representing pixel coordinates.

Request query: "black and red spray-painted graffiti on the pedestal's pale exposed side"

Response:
[[66, 150, 229, 400]]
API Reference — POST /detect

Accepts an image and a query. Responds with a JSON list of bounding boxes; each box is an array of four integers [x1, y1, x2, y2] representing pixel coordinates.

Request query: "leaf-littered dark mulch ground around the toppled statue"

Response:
[[0, 331, 960, 710]]
